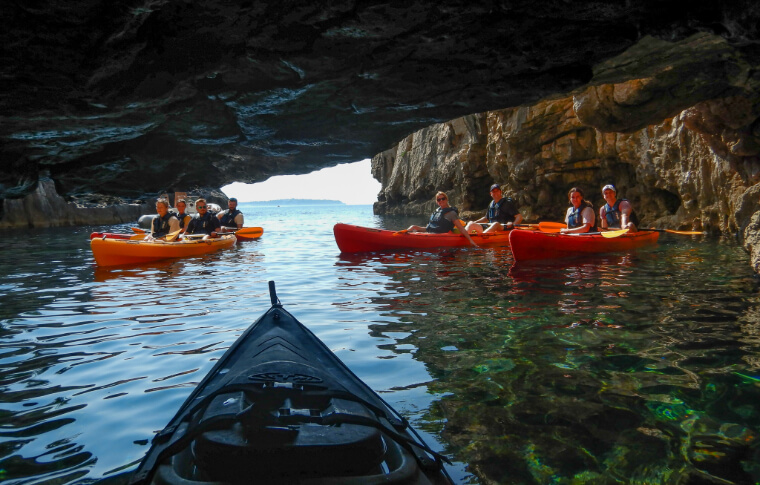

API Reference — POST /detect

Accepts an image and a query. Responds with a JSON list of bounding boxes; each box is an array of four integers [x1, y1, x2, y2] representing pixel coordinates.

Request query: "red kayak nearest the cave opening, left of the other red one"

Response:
[[333, 223, 509, 253]]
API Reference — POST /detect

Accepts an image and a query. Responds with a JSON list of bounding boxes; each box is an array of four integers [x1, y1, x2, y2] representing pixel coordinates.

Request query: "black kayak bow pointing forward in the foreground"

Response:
[[130, 281, 451, 485]]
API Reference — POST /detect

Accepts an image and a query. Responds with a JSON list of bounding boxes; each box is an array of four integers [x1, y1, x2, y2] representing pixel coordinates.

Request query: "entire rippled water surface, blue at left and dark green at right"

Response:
[[0, 204, 760, 484]]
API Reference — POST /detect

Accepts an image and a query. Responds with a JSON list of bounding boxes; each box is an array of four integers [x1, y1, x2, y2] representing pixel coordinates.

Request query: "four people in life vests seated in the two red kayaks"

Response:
[[407, 184, 639, 246]]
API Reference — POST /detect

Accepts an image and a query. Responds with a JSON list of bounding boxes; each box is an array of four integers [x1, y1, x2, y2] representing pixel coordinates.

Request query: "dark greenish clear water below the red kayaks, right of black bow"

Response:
[[338, 240, 760, 483]]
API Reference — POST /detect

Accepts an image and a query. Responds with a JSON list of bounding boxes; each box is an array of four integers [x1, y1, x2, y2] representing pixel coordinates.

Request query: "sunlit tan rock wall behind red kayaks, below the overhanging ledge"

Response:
[[372, 92, 760, 271]]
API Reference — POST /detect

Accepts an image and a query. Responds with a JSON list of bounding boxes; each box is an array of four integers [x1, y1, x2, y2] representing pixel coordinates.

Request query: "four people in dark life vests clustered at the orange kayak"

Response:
[[145, 197, 244, 240]]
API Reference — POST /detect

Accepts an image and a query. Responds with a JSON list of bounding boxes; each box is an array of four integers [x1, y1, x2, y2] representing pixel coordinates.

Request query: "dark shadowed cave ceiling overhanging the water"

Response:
[[0, 0, 760, 199]]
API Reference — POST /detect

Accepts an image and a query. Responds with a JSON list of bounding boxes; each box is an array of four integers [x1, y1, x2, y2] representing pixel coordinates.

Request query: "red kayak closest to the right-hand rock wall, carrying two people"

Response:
[[509, 229, 660, 262]]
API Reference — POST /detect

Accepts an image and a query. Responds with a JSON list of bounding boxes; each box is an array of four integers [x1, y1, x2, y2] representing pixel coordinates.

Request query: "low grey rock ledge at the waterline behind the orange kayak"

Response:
[[0, 179, 155, 229]]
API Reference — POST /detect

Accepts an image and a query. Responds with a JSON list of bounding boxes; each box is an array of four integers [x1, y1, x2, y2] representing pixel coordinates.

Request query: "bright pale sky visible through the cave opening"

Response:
[[222, 159, 380, 205]]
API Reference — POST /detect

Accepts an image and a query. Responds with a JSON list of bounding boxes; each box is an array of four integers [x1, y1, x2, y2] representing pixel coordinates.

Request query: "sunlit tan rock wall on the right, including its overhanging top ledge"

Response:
[[372, 30, 760, 270]]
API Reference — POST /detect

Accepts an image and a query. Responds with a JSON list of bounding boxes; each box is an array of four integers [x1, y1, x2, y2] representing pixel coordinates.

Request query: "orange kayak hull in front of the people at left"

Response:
[[90, 235, 236, 266]]
